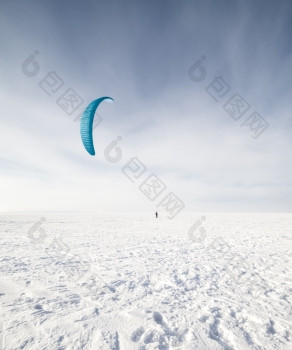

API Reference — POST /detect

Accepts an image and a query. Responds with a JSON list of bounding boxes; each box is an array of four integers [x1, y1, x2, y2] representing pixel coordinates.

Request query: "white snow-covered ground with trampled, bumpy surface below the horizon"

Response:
[[0, 213, 292, 350]]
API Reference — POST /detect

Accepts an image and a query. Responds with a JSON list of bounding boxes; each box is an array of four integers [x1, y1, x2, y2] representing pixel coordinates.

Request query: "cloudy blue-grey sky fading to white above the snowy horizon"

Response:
[[0, 0, 292, 215]]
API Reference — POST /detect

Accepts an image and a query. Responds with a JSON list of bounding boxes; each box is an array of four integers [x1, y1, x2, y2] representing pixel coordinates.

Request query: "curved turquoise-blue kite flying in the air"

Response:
[[80, 96, 113, 156]]
